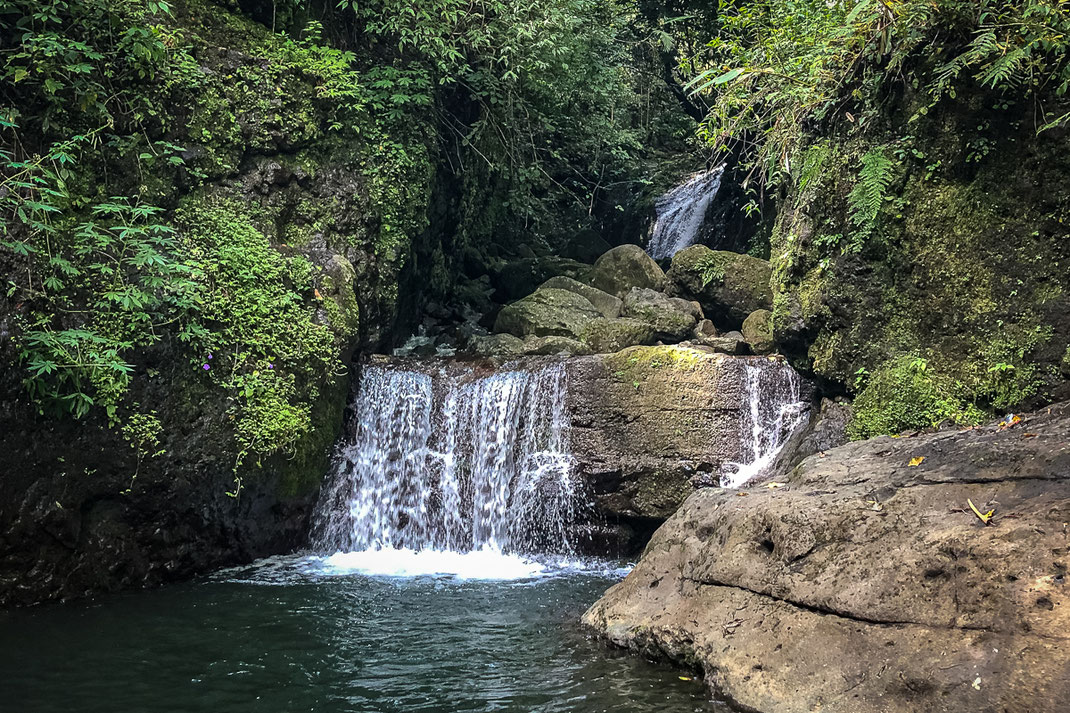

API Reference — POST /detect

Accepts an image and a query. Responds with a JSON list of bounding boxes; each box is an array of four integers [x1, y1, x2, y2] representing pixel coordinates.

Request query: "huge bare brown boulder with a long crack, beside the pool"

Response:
[[584, 404, 1070, 713]]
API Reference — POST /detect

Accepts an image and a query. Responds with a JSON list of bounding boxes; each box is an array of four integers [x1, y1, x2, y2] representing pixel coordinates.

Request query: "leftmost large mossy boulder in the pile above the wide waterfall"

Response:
[[494, 288, 603, 338]]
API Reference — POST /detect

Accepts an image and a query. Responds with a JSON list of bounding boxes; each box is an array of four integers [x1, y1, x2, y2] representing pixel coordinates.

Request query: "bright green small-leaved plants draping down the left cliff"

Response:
[[177, 199, 339, 461]]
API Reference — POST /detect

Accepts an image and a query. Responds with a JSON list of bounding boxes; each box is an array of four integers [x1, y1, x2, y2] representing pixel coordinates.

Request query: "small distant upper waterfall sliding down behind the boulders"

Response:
[[646, 166, 724, 260]]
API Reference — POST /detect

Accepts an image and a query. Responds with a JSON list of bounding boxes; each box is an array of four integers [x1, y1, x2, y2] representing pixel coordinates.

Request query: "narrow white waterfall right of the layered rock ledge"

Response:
[[721, 359, 810, 488]]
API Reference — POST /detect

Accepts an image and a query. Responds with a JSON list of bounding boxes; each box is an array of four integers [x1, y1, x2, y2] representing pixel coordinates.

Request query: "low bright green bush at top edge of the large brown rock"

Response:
[[849, 355, 984, 439]]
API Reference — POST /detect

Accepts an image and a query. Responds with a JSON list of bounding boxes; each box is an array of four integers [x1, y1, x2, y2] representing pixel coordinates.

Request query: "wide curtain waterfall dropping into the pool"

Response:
[[314, 363, 578, 553]]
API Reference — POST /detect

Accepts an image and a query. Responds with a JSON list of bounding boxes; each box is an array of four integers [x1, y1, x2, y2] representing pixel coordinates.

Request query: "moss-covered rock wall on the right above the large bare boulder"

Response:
[[773, 96, 1070, 436]]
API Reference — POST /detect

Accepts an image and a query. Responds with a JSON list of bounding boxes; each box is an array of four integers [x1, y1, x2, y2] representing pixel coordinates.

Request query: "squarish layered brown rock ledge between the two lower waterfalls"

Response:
[[568, 347, 745, 520]]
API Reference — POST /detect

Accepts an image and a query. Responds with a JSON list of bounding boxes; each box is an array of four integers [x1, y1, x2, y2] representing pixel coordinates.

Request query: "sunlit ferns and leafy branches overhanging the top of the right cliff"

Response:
[[693, 0, 1070, 184]]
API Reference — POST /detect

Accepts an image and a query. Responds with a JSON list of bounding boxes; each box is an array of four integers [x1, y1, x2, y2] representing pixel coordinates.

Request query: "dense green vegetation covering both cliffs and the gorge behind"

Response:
[[0, 0, 1070, 465]]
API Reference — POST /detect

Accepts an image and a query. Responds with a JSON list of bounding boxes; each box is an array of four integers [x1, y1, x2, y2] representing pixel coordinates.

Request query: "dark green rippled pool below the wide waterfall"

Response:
[[0, 558, 727, 713]]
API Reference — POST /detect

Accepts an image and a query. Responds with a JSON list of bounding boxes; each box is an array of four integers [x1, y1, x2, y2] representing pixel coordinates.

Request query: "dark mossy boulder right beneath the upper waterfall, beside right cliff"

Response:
[[667, 245, 773, 327]]
